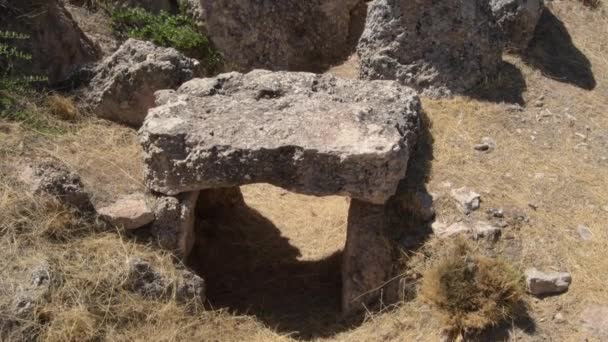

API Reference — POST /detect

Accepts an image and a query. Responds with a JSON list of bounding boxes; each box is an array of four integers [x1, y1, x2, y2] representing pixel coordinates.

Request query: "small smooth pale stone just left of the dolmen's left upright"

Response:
[[97, 194, 154, 229]]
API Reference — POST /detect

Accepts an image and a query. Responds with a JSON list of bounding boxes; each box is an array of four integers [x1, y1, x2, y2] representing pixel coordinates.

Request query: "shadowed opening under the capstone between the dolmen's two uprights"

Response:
[[189, 184, 352, 339]]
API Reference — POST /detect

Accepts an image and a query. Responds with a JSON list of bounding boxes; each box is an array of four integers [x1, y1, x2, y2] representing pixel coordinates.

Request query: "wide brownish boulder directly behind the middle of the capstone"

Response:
[[202, 0, 362, 72]]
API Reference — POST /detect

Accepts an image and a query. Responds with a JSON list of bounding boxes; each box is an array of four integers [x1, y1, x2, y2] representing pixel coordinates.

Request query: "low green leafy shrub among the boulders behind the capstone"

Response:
[[111, 8, 220, 72]]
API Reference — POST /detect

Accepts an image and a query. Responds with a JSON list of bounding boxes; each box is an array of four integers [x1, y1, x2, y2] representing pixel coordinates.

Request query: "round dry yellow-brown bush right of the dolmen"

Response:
[[420, 239, 524, 336]]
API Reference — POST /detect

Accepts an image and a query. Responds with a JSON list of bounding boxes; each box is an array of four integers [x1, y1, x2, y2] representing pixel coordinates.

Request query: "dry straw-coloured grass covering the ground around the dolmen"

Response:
[[0, 1, 608, 342]]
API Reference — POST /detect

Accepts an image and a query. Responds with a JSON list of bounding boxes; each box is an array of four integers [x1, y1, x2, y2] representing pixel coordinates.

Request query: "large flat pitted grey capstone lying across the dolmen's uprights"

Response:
[[139, 70, 420, 204]]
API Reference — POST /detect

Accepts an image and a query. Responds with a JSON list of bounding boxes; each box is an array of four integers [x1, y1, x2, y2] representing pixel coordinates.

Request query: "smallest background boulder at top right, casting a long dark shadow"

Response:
[[490, 0, 545, 51]]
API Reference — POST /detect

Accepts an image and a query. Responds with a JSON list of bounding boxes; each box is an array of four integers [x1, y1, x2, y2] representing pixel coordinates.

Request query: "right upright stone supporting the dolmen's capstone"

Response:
[[342, 199, 393, 314]]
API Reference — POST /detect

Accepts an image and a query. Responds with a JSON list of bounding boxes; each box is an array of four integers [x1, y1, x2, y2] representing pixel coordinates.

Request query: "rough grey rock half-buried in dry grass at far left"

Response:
[[19, 160, 92, 210]]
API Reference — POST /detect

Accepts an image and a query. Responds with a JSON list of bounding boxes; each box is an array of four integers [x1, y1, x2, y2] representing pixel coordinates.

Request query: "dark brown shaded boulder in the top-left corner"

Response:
[[0, 0, 99, 85]]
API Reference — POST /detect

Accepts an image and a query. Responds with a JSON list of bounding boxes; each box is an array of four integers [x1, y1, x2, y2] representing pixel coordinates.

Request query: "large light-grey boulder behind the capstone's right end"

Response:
[[357, 0, 502, 96]]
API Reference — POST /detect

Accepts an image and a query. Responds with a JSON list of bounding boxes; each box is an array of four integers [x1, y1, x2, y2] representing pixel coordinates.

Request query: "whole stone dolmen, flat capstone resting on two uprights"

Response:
[[139, 70, 421, 314]]
